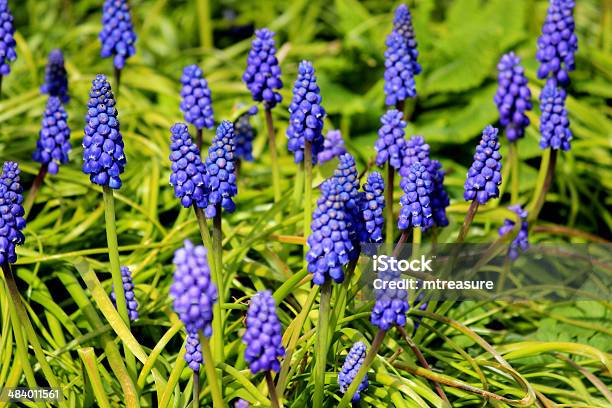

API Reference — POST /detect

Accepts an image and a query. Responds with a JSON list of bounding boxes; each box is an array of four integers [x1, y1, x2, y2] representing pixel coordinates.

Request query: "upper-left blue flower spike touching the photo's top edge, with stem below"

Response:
[[98, 0, 136, 69]]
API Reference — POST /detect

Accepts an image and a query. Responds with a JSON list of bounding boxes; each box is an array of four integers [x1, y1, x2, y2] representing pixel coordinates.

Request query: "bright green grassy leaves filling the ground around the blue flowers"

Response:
[[0, 0, 612, 407]]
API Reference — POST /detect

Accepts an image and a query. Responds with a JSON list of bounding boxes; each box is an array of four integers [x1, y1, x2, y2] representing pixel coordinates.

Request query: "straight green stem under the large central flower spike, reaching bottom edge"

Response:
[[314, 278, 332, 408]]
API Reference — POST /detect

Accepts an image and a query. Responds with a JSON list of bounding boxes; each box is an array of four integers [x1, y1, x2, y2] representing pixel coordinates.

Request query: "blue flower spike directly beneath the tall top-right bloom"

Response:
[[540, 79, 572, 151]]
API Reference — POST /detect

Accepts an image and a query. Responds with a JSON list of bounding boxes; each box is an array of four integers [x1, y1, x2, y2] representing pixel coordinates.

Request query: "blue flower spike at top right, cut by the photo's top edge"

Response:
[[536, 0, 578, 86]]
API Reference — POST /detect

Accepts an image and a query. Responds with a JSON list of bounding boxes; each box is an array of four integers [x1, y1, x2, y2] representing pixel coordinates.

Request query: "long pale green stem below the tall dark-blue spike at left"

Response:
[[102, 186, 136, 380]]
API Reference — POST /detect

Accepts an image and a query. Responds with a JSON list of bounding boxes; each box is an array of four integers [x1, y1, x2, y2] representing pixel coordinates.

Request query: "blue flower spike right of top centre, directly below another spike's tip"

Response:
[[384, 31, 416, 106]]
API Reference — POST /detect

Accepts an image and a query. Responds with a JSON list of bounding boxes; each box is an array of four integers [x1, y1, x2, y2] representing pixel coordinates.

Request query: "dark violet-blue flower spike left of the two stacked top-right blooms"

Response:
[[493, 52, 531, 142]]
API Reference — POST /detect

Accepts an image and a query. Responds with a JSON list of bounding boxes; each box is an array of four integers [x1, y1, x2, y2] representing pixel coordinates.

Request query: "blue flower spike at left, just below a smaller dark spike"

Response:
[[32, 96, 71, 174]]
